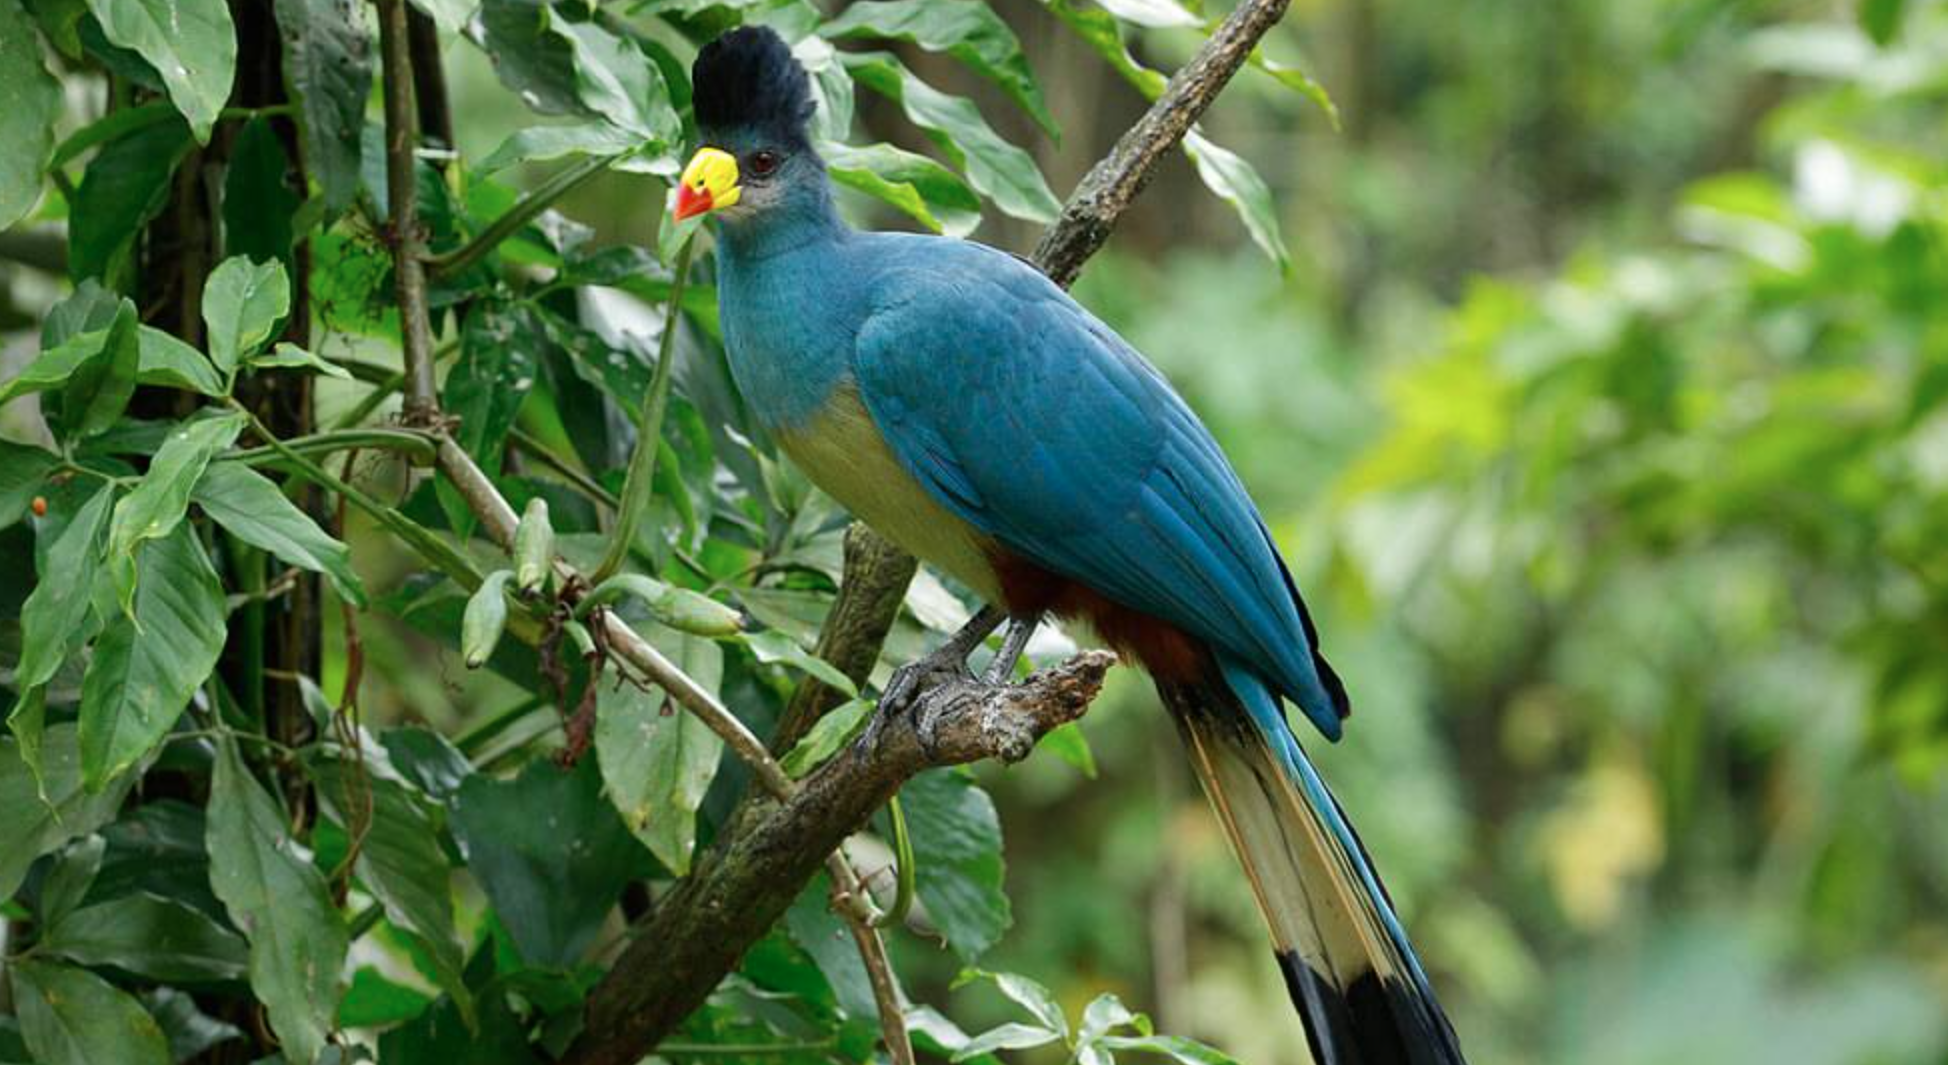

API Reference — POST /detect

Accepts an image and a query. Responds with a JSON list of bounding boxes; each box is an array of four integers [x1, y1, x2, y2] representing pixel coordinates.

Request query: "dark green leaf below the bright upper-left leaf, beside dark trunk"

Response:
[[68, 119, 191, 280]]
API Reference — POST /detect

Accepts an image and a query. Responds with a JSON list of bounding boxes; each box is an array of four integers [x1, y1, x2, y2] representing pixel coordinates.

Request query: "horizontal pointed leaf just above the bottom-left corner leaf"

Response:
[[41, 892, 249, 983]]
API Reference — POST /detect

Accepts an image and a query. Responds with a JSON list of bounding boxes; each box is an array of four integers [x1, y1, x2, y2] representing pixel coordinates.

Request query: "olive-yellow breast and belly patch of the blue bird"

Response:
[[777, 384, 1001, 604]]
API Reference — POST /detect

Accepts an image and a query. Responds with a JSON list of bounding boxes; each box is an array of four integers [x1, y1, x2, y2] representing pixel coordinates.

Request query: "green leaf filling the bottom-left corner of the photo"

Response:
[[10, 962, 171, 1065]]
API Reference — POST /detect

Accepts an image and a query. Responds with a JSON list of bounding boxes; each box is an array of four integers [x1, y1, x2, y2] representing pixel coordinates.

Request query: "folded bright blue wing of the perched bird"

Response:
[[853, 239, 1344, 738]]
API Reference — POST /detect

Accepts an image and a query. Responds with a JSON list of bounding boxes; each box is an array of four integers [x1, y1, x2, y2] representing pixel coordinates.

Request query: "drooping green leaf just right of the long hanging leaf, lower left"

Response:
[[310, 759, 473, 1016]]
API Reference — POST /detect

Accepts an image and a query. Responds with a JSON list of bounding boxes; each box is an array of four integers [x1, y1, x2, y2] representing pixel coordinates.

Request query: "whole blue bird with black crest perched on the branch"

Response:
[[676, 27, 1461, 1065]]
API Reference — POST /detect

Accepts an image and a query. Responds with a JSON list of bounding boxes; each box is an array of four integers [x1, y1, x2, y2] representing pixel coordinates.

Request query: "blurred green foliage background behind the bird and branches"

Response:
[[0, 0, 1948, 1065]]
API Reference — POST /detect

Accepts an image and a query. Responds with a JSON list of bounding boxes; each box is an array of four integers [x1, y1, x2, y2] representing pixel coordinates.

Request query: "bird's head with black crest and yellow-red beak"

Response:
[[676, 25, 824, 222]]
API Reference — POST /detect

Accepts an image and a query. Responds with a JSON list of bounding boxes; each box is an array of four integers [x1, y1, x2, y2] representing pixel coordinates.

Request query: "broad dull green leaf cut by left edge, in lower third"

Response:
[[0, 722, 132, 900]]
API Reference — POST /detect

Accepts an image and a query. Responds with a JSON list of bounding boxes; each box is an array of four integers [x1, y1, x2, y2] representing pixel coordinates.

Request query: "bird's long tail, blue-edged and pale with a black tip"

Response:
[[1157, 662, 1463, 1065]]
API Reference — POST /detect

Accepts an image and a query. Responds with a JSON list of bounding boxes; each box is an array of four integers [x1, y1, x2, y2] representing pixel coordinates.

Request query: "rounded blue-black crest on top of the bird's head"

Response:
[[690, 25, 818, 140]]
